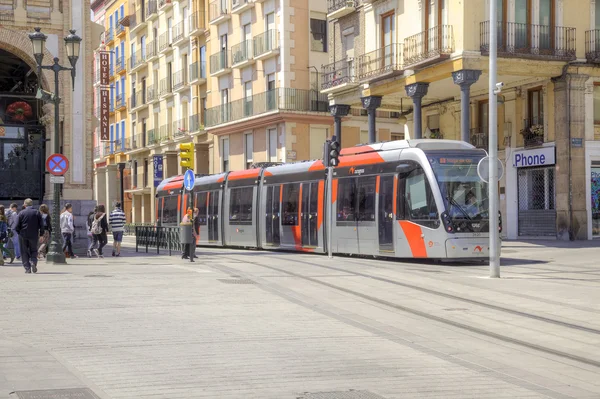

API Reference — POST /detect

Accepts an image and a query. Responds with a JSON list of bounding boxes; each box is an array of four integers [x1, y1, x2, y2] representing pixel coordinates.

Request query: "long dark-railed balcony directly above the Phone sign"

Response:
[[480, 21, 576, 61]]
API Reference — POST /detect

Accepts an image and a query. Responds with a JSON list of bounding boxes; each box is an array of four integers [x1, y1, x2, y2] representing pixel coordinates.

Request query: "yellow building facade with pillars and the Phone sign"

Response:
[[322, 0, 600, 239]]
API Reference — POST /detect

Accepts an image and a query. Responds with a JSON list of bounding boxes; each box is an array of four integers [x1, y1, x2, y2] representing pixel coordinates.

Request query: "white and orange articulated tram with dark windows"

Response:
[[156, 139, 502, 259]]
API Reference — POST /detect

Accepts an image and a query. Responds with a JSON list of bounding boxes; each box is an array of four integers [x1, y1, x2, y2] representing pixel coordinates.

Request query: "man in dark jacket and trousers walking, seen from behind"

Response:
[[16, 198, 44, 273]]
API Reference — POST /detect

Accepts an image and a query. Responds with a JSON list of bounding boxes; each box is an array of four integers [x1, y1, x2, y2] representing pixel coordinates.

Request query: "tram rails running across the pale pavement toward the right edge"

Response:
[[221, 256, 600, 368]]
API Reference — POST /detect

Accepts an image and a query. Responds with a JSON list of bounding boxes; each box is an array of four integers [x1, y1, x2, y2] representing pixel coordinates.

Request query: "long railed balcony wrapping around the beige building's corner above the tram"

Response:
[[206, 88, 329, 127]]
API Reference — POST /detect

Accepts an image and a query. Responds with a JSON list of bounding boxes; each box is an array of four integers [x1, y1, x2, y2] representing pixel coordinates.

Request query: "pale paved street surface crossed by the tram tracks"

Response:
[[0, 241, 600, 399]]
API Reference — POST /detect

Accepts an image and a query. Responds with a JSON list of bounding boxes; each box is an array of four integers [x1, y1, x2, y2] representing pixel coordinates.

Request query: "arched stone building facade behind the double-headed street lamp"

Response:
[[0, 0, 99, 237]]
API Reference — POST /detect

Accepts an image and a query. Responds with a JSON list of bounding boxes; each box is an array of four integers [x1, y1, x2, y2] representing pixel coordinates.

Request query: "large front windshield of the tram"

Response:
[[428, 151, 489, 221]]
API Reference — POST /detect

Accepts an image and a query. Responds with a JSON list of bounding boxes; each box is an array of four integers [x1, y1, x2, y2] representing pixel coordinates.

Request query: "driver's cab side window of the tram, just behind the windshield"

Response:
[[397, 168, 440, 229]]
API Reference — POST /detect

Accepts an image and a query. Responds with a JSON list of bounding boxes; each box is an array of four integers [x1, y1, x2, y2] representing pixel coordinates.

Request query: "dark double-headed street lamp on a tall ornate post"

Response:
[[29, 28, 81, 263]]
